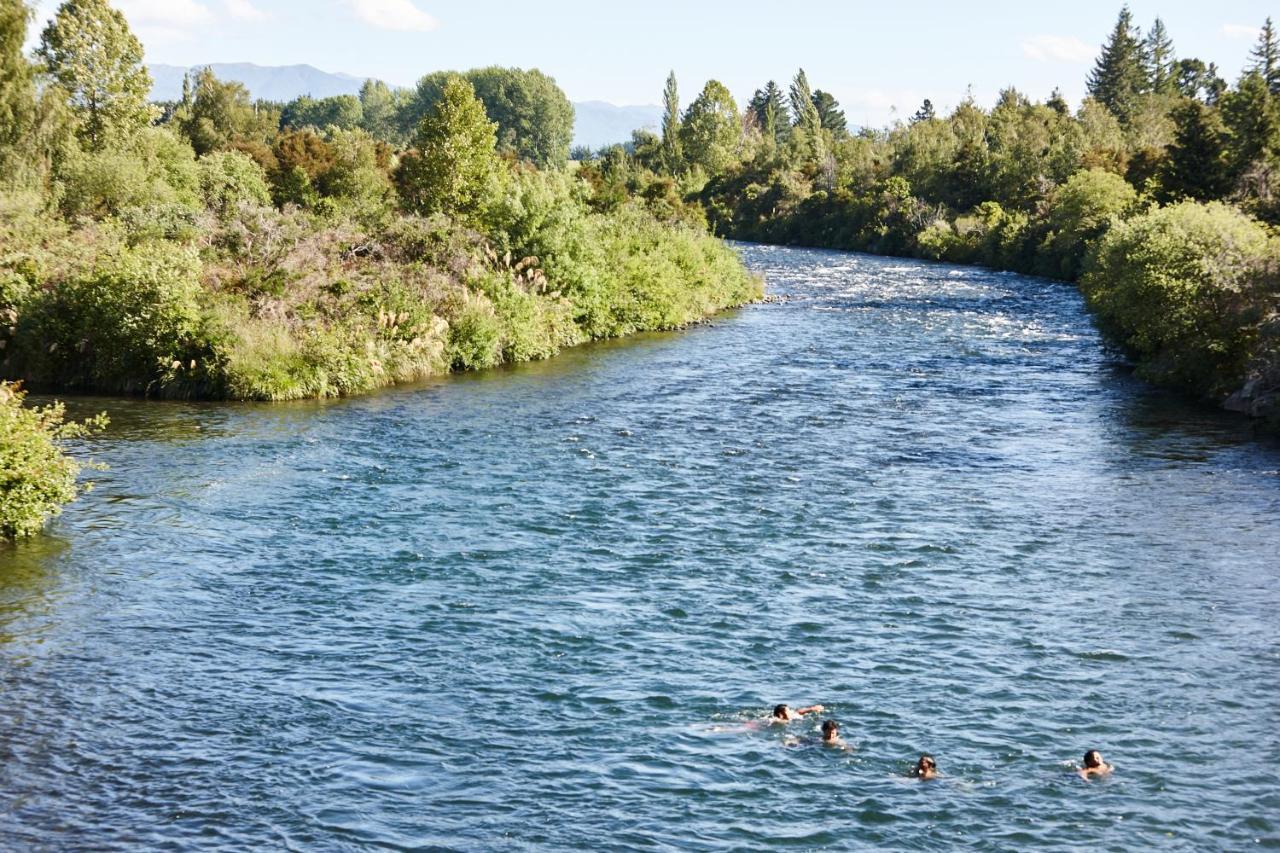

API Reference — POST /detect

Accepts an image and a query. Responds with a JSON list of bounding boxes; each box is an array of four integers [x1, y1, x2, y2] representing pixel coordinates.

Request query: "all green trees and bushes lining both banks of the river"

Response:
[[0, 0, 1280, 537]]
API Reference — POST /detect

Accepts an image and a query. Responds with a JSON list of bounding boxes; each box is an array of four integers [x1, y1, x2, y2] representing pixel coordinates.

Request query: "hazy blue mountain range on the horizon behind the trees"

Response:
[[150, 63, 662, 149]]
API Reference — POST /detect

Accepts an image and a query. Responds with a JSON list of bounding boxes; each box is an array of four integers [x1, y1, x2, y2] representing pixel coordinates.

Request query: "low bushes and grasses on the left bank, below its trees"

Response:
[[0, 188, 763, 401]]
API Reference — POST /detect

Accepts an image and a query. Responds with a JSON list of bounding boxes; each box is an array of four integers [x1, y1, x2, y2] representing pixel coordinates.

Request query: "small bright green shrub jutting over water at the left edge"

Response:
[[0, 383, 106, 539]]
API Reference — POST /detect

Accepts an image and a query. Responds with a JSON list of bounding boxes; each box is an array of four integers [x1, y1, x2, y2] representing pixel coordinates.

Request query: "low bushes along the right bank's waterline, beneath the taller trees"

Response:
[[707, 184, 1280, 433]]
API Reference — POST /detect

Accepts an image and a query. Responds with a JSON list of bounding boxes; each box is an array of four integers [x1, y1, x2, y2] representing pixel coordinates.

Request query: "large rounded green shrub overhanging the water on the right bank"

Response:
[[1080, 201, 1268, 397]]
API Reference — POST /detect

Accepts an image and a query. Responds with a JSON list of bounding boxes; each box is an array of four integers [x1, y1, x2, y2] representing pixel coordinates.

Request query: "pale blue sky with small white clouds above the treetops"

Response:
[[22, 0, 1280, 126]]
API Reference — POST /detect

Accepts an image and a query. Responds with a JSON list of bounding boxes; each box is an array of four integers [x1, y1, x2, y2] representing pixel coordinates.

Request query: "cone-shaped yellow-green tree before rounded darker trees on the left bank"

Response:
[[397, 74, 502, 219]]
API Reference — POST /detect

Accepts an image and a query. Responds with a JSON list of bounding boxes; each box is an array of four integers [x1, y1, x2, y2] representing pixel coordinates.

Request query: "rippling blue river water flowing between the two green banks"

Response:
[[0, 246, 1280, 850]]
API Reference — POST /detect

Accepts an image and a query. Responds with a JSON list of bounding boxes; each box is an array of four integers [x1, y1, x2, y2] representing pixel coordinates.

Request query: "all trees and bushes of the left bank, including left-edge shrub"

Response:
[[0, 0, 763, 539]]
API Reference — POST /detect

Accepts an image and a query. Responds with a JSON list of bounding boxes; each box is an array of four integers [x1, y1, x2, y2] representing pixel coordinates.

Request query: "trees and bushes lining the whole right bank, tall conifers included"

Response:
[[575, 8, 1280, 430]]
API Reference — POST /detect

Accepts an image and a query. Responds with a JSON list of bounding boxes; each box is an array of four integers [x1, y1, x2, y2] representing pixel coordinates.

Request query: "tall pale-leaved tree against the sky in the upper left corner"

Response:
[[37, 0, 152, 151]]
